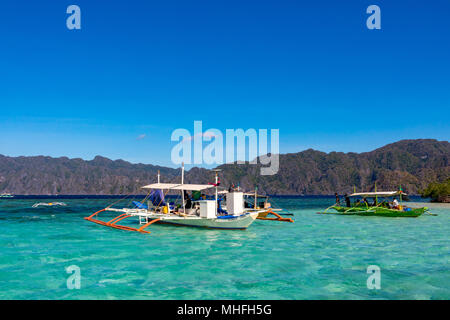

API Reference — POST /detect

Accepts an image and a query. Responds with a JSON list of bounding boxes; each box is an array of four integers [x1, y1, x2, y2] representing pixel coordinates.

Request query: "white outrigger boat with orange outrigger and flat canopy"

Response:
[[85, 167, 264, 233]]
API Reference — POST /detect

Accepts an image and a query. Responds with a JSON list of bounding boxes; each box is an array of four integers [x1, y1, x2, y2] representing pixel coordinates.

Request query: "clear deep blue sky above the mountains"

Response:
[[0, 0, 450, 166]]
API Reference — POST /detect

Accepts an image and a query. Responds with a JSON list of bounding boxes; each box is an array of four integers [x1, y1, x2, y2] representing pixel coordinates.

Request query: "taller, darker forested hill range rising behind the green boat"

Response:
[[216, 139, 450, 195]]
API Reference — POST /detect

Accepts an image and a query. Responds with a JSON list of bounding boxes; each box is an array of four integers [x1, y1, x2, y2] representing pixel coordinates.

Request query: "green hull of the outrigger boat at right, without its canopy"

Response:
[[324, 206, 428, 218]]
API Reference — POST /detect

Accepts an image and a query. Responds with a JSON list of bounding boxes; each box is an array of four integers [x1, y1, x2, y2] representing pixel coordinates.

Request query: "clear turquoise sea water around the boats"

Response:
[[0, 197, 450, 299]]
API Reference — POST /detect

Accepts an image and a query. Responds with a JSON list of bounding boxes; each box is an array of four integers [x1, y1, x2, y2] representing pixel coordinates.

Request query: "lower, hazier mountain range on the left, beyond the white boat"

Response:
[[0, 155, 180, 195]]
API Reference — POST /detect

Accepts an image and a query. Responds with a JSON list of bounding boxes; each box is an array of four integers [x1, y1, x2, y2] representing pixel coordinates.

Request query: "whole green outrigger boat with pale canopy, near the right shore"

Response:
[[318, 190, 429, 218]]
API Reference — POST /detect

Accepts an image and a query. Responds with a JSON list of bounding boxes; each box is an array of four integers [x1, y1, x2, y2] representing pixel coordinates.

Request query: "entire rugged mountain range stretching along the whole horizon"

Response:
[[0, 139, 450, 195]]
